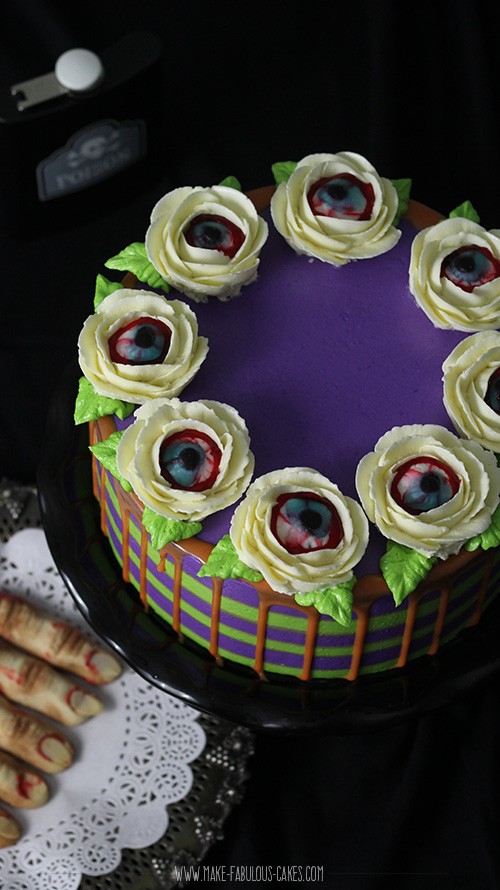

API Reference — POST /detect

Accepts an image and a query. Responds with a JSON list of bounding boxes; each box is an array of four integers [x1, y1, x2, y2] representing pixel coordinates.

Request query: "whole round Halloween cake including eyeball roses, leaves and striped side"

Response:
[[75, 152, 500, 682]]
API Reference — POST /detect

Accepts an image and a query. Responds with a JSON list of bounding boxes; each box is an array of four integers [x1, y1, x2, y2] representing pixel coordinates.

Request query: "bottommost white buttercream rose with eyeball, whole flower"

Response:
[[230, 467, 368, 595]]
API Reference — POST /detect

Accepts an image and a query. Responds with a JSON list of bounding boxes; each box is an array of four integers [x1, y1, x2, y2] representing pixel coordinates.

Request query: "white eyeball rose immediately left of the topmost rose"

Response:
[[146, 186, 268, 301]]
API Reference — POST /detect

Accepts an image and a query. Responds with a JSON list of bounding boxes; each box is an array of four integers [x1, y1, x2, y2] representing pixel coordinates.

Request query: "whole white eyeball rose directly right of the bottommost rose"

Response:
[[356, 424, 500, 559]]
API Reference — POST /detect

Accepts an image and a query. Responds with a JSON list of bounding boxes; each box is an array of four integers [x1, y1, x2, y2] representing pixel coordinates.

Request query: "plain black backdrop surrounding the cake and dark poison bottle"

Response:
[[0, 0, 500, 890]]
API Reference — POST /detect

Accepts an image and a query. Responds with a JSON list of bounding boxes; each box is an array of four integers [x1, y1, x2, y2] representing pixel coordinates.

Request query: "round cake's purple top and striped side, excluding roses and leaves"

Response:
[[90, 182, 500, 680]]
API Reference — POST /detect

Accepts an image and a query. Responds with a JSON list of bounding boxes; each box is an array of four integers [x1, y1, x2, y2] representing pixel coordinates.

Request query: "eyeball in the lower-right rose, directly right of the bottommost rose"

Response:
[[391, 456, 460, 516]]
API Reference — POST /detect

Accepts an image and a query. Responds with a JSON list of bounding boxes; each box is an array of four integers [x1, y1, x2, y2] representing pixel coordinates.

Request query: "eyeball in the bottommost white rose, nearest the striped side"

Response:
[[271, 491, 344, 554]]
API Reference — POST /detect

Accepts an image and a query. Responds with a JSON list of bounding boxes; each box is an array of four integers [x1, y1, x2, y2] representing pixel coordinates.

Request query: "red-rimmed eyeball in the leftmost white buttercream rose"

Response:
[[108, 316, 172, 365]]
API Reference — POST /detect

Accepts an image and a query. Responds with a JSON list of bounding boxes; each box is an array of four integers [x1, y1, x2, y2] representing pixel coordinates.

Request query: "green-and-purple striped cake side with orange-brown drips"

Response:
[[91, 424, 500, 680]]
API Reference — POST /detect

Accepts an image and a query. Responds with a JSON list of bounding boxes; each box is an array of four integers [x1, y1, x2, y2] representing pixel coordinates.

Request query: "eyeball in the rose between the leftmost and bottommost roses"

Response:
[[159, 430, 222, 491]]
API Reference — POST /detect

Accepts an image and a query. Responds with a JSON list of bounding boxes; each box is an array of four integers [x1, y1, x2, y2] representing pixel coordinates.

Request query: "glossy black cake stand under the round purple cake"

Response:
[[38, 362, 500, 734]]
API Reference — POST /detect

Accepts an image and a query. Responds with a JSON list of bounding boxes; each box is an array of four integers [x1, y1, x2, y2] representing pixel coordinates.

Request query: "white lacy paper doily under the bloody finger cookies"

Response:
[[0, 528, 206, 890]]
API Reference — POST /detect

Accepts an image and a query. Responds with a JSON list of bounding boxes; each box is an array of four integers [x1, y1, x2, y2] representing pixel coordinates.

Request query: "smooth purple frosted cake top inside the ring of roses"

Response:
[[116, 211, 465, 577]]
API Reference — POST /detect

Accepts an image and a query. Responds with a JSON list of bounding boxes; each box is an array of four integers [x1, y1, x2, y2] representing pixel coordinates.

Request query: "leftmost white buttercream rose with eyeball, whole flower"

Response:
[[78, 288, 208, 404]]
